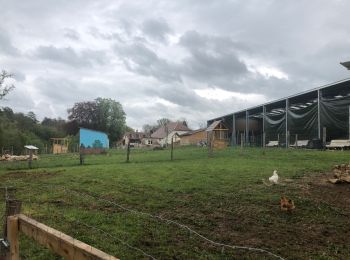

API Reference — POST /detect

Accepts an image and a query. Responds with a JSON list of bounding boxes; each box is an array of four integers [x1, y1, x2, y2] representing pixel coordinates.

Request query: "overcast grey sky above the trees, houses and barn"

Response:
[[0, 0, 350, 129]]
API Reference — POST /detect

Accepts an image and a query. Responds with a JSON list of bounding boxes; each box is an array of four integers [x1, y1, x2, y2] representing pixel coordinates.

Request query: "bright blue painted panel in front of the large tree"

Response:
[[79, 128, 109, 148]]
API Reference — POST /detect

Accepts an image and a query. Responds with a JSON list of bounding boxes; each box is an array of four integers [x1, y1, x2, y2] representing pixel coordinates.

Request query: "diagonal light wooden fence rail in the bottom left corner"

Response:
[[16, 214, 117, 260]]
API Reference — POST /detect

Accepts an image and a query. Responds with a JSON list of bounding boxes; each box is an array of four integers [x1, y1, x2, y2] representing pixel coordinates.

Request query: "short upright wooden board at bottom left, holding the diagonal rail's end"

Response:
[[6, 216, 19, 260]]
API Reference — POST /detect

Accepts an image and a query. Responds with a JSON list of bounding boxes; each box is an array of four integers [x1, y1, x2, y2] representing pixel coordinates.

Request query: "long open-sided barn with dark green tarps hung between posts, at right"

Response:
[[207, 79, 350, 147]]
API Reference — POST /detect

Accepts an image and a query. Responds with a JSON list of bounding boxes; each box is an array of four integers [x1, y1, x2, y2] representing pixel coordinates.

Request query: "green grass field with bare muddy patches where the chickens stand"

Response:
[[0, 148, 350, 259]]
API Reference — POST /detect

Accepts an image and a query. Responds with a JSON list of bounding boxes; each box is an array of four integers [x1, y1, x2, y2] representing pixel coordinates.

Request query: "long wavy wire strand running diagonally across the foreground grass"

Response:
[[5, 183, 285, 260]]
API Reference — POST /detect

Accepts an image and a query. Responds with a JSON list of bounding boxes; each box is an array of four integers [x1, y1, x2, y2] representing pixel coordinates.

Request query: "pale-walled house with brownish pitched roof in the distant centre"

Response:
[[151, 121, 191, 146]]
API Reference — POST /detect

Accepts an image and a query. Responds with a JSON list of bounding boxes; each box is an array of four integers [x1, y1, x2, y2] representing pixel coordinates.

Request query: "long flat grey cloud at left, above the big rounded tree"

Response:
[[35, 45, 106, 67]]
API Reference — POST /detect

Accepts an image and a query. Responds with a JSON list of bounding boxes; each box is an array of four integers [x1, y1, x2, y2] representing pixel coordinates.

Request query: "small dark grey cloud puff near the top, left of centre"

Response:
[[142, 18, 172, 42]]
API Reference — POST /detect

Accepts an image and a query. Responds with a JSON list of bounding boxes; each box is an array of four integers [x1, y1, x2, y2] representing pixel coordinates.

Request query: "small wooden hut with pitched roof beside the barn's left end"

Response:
[[206, 120, 229, 149]]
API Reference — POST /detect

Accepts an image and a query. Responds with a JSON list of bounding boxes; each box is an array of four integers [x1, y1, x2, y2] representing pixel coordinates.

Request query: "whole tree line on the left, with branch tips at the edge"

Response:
[[0, 71, 131, 154]]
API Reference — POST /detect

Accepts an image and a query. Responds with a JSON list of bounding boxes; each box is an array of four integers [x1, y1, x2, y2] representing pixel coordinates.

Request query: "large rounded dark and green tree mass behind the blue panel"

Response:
[[68, 98, 126, 143]]
